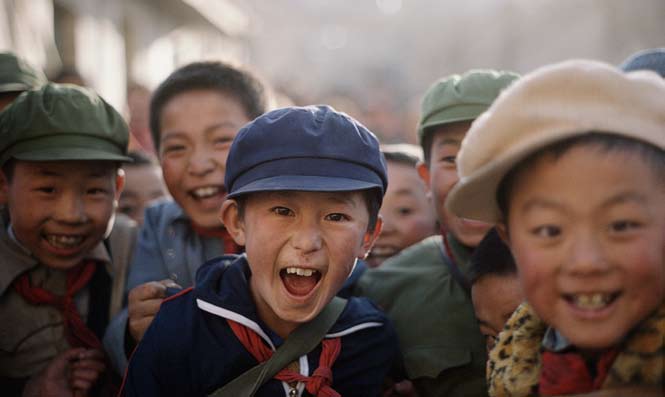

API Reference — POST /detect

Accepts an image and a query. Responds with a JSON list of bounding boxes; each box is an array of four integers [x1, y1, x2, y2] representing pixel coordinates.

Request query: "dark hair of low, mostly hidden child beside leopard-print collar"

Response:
[[469, 228, 517, 284]]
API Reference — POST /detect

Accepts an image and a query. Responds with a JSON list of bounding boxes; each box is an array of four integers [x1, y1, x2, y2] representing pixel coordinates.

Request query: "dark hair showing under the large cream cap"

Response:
[[496, 131, 665, 219]]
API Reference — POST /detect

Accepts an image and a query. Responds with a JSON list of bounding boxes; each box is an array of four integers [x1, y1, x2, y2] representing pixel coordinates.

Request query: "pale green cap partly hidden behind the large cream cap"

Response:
[[418, 70, 519, 144]]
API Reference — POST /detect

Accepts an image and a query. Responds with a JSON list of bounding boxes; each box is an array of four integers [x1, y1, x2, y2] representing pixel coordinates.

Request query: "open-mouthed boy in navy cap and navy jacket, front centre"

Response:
[[122, 106, 398, 397]]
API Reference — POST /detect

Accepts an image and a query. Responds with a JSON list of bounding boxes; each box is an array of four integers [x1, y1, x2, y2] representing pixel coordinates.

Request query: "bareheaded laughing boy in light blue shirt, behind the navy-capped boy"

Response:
[[104, 62, 267, 373]]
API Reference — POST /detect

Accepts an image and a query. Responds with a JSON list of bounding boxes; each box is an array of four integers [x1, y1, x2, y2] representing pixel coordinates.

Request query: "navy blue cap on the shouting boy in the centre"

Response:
[[224, 105, 388, 198]]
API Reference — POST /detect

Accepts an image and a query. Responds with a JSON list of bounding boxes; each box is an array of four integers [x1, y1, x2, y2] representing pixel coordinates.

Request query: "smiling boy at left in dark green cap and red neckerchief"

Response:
[[0, 84, 134, 396]]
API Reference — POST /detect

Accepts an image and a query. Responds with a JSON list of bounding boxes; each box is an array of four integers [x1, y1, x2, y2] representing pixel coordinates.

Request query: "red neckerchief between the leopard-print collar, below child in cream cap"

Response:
[[538, 349, 618, 396]]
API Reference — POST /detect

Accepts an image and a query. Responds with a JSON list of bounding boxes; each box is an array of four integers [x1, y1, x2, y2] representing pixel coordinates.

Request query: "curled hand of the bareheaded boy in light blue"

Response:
[[127, 279, 182, 343]]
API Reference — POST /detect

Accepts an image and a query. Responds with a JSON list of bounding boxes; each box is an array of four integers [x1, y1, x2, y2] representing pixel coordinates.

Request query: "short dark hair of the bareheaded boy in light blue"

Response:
[[150, 62, 268, 150]]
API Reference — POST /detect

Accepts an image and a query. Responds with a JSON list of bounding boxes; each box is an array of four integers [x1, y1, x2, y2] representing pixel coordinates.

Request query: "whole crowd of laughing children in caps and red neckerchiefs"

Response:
[[0, 49, 665, 397]]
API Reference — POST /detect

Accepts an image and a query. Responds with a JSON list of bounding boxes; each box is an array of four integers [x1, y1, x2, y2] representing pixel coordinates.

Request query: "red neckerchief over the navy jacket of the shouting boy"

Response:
[[226, 319, 342, 397]]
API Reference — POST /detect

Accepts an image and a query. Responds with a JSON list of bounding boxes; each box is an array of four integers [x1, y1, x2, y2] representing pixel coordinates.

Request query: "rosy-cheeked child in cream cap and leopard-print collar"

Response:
[[447, 61, 665, 396]]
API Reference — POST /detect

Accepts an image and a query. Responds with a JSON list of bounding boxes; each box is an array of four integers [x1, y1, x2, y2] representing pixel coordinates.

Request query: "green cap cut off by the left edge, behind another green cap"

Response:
[[0, 52, 48, 93]]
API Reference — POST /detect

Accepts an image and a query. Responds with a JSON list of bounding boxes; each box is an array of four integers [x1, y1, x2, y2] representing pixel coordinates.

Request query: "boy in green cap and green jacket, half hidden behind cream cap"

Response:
[[356, 70, 518, 396]]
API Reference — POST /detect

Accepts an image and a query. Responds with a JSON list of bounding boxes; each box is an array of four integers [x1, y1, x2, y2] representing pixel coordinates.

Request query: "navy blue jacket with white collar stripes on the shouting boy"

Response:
[[121, 255, 399, 397]]
